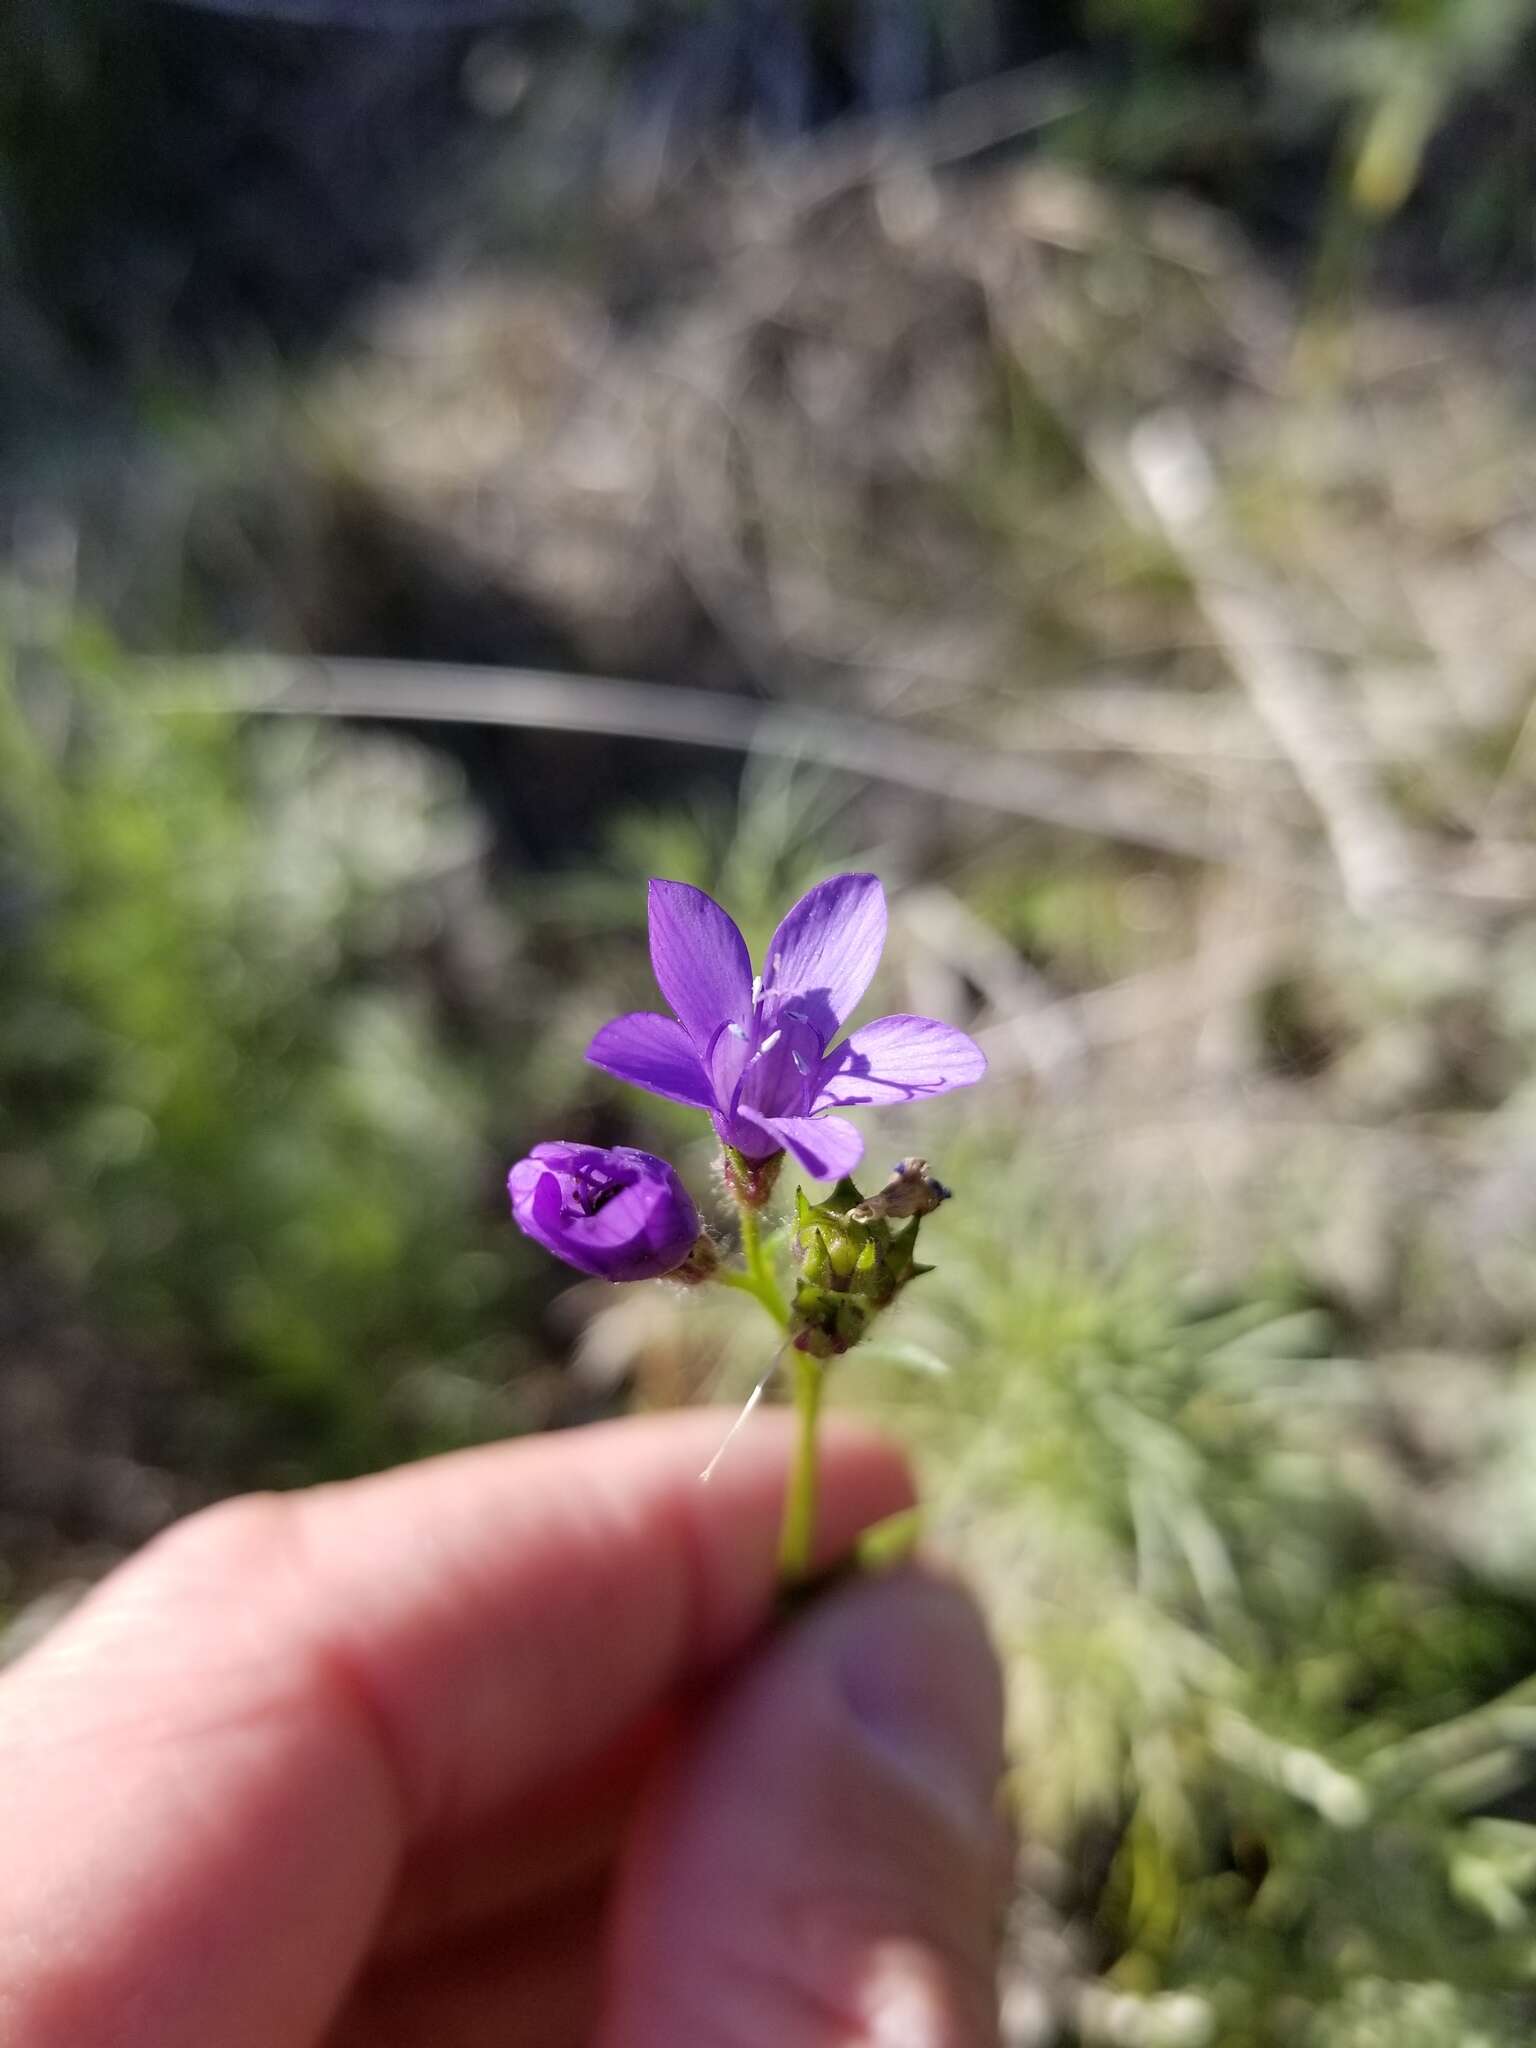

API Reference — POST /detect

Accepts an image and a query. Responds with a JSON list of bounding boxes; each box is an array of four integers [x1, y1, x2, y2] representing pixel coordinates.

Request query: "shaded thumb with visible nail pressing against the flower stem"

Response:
[[598, 1573, 1004, 2048]]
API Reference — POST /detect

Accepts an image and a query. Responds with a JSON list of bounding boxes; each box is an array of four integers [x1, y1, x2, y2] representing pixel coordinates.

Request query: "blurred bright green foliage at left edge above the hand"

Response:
[[0, 598, 516, 1470]]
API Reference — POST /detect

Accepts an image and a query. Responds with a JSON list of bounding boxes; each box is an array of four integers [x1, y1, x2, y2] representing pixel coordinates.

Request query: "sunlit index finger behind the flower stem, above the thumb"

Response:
[[0, 1415, 909, 2048]]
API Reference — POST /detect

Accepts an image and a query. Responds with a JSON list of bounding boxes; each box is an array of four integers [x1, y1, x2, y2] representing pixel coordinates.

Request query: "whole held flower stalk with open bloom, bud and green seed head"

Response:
[[510, 874, 987, 1585]]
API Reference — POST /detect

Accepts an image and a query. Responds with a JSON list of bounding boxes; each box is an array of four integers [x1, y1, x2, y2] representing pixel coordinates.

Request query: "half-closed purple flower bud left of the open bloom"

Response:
[[506, 1139, 698, 1280]]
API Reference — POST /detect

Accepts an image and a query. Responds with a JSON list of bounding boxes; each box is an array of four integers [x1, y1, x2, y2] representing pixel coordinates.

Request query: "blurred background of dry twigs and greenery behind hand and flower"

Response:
[[0, 0, 1536, 2048]]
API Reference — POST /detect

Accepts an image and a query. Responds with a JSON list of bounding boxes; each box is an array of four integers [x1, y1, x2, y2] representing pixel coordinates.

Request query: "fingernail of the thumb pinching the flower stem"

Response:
[[838, 1573, 1004, 1851]]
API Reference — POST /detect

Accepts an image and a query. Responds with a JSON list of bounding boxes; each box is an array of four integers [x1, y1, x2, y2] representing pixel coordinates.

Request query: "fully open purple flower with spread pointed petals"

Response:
[[586, 874, 987, 1180]]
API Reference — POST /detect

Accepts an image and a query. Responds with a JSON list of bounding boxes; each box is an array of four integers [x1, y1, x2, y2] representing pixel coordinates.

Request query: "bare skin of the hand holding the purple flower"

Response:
[[0, 1415, 1001, 2048]]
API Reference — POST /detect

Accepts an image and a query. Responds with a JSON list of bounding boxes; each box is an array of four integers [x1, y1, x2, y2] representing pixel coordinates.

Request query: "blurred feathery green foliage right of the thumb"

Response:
[[838, 1149, 1536, 2048]]
